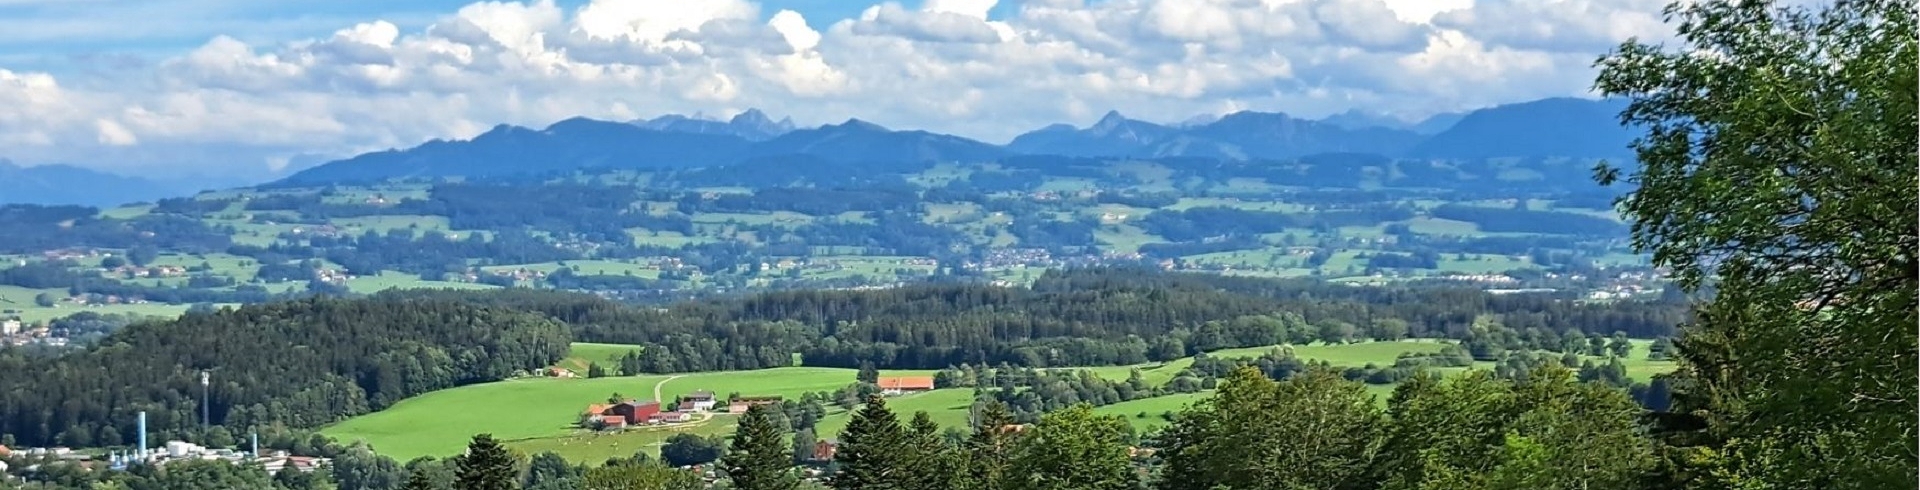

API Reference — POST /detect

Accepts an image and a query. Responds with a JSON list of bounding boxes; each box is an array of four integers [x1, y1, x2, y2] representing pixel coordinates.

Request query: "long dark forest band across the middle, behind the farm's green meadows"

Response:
[[407, 269, 1688, 373]]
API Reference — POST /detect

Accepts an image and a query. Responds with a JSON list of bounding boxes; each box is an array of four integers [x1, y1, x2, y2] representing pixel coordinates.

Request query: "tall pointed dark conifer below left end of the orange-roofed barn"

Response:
[[831, 396, 914, 490]]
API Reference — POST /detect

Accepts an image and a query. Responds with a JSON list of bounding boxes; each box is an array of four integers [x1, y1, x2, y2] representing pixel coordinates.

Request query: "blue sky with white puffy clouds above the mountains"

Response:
[[0, 0, 1670, 175]]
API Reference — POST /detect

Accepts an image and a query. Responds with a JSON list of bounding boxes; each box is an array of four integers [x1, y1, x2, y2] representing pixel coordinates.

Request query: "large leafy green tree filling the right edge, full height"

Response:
[[1597, 0, 1920, 488]]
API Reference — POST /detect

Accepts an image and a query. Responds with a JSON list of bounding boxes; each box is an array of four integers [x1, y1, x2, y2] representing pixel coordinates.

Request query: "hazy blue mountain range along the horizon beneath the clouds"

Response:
[[0, 98, 1634, 200]]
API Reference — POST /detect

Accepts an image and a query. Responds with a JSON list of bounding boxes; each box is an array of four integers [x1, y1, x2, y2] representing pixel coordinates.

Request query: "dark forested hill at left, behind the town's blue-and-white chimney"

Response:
[[0, 298, 570, 448]]
